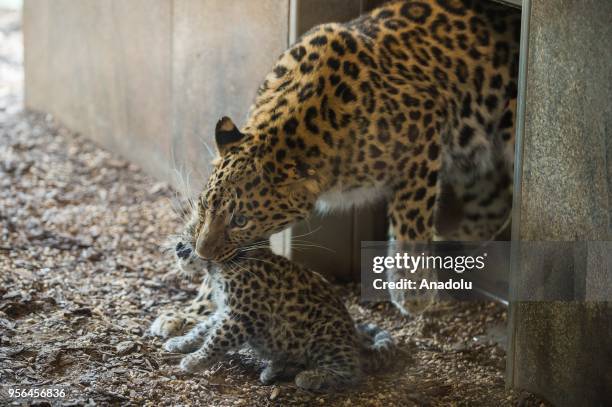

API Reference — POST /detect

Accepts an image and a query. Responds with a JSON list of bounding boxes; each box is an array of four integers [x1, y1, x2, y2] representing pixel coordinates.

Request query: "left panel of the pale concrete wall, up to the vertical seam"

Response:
[[23, 0, 172, 182]]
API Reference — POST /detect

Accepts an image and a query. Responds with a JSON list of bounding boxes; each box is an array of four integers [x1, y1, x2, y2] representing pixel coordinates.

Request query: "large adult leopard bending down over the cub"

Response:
[[152, 0, 520, 324]]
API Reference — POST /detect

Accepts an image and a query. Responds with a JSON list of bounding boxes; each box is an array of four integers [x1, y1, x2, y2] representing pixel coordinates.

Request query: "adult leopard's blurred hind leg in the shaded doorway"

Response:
[[436, 96, 517, 241]]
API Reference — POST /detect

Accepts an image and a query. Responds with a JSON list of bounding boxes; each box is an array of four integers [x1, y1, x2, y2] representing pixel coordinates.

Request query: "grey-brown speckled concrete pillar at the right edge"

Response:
[[508, 0, 612, 406]]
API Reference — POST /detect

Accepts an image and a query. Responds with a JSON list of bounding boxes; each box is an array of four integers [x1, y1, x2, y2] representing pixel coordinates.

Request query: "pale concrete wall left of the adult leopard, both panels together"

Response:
[[23, 0, 289, 185]]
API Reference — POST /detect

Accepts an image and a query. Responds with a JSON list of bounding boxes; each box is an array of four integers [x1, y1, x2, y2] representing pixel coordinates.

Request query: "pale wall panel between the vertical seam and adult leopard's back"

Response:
[[171, 0, 289, 182]]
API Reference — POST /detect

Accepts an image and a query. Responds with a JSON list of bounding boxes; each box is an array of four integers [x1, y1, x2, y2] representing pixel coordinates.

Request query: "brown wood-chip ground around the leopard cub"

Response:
[[0, 7, 539, 406]]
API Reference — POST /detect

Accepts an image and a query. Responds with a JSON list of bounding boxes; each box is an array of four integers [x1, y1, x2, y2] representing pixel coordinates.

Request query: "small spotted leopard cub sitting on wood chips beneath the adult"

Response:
[[164, 245, 395, 391]]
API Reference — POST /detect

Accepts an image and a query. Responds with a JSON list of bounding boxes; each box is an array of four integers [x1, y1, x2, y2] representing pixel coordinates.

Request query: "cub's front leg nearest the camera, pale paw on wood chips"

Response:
[[174, 318, 245, 372]]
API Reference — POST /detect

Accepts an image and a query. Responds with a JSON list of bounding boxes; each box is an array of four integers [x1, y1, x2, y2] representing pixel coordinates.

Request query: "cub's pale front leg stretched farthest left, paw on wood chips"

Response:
[[149, 277, 215, 339]]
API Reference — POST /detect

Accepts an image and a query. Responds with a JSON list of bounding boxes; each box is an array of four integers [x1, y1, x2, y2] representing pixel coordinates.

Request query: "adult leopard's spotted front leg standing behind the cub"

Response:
[[387, 160, 439, 316]]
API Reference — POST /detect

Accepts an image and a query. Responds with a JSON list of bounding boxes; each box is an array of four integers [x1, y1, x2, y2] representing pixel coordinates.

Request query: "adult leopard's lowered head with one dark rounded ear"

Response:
[[193, 117, 318, 262]]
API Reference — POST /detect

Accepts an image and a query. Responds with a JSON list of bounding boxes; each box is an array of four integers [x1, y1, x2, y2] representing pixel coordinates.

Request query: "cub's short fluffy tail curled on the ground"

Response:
[[357, 324, 397, 373]]
